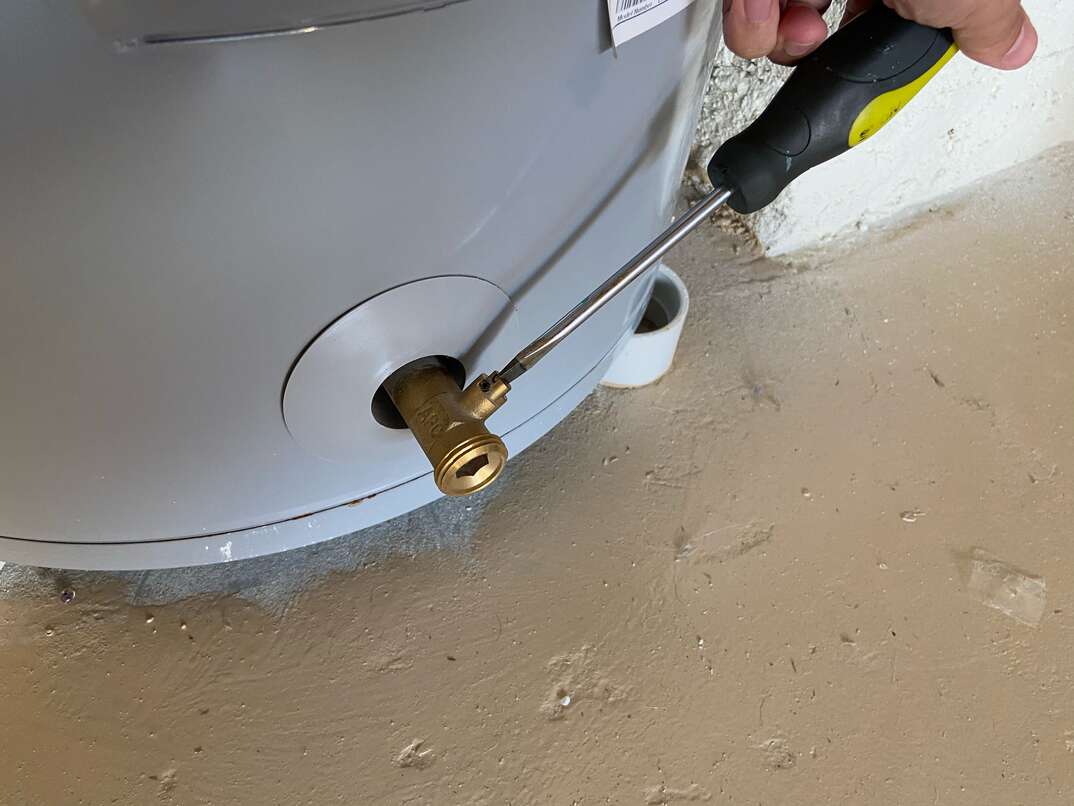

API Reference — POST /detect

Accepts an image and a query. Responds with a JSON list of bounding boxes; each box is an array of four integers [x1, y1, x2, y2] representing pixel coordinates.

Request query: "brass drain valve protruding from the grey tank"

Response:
[[383, 356, 510, 495]]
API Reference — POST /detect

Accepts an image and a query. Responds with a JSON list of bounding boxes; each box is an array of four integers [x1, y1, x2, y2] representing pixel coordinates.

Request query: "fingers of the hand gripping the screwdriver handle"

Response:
[[723, 0, 1036, 70]]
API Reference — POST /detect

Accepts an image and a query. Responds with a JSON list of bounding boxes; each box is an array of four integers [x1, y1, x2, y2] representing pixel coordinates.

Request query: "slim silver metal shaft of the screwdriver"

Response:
[[496, 187, 734, 384]]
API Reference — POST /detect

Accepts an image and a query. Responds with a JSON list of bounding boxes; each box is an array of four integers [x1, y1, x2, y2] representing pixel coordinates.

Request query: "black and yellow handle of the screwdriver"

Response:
[[709, 2, 958, 213]]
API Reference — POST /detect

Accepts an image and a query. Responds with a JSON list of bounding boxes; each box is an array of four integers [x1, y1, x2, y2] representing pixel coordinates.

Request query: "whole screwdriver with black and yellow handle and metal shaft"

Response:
[[490, 2, 958, 388]]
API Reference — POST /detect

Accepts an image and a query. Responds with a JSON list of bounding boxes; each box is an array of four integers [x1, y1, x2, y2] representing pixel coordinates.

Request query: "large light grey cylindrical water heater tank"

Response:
[[0, 0, 714, 568]]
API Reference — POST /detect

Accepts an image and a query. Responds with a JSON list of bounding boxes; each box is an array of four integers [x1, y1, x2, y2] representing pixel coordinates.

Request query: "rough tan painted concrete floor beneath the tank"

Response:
[[6, 149, 1074, 806]]
